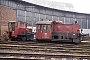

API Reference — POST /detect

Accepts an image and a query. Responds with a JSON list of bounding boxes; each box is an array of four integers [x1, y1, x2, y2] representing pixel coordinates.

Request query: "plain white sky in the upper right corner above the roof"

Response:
[[50, 0, 90, 14]]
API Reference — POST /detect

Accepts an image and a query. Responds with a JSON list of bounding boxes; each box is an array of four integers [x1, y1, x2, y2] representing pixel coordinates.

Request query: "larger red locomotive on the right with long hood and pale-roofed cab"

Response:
[[36, 20, 81, 43]]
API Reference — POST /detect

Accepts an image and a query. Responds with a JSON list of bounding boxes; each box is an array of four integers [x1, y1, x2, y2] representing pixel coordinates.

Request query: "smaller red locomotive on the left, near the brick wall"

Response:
[[8, 21, 34, 41]]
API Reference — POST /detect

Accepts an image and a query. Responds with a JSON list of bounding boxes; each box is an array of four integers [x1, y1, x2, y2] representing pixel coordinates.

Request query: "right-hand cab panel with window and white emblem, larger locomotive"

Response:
[[41, 24, 51, 40]]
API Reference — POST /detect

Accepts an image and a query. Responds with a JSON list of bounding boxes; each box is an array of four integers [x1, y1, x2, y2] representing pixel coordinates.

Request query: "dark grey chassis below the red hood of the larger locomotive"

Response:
[[52, 32, 87, 43]]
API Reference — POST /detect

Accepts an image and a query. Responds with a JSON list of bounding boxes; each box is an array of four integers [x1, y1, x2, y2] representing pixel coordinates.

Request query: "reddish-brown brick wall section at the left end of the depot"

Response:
[[0, 6, 16, 35]]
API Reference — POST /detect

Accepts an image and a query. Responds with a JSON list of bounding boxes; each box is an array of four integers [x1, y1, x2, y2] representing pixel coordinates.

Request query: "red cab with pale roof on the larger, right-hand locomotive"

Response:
[[36, 21, 51, 41]]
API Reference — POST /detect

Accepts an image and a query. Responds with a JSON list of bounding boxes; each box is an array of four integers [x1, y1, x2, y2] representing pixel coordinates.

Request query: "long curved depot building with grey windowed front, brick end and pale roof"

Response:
[[0, 0, 90, 35]]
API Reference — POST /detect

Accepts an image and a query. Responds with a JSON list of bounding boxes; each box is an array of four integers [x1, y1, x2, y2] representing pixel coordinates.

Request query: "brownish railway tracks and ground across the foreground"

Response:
[[0, 41, 90, 60]]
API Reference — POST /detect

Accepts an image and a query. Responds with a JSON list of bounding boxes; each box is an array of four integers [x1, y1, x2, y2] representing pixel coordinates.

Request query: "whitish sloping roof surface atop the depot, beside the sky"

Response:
[[22, 0, 74, 11]]
